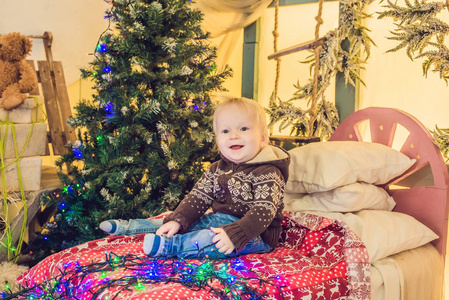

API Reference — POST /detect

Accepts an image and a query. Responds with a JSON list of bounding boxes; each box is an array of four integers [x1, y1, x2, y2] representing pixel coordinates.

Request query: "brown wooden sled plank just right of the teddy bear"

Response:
[[37, 61, 66, 155]]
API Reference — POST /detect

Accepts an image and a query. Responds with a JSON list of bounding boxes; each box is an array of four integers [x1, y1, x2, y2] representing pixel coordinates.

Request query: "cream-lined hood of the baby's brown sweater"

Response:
[[221, 145, 290, 182]]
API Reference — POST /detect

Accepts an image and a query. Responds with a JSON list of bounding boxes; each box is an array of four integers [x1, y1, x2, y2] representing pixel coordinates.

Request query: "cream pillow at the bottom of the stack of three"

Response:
[[302, 210, 438, 263]]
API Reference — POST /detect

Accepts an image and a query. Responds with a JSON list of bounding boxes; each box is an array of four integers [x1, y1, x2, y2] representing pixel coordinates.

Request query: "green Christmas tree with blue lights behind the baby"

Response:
[[29, 0, 231, 257]]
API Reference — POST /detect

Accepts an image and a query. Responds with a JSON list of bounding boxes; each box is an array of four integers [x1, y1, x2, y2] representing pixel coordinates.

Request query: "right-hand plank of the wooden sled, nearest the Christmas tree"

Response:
[[53, 61, 76, 144]]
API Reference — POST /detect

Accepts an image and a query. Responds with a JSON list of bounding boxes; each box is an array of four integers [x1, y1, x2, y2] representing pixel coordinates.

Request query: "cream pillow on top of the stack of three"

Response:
[[285, 141, 415, 193]]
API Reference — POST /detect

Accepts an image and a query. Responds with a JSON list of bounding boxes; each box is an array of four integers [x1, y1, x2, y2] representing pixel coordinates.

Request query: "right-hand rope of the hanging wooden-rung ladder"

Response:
[[309, 0, 324, 137]]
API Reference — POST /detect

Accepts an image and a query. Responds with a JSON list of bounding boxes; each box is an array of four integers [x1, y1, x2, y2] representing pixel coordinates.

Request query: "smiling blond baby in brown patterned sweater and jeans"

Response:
[[100, 98, 290, 258]]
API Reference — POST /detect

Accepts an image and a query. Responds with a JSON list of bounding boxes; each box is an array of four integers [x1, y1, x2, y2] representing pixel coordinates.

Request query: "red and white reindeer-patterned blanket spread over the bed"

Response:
[[16, 212, 371, 300]]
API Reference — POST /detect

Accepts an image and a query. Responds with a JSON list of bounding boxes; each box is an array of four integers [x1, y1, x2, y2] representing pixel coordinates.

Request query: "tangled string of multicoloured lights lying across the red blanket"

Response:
[[1, 252, 284, 300]]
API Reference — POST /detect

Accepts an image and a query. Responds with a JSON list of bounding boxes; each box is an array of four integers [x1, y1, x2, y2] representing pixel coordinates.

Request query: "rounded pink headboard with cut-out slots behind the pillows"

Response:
[[330, 107, 449, 257]]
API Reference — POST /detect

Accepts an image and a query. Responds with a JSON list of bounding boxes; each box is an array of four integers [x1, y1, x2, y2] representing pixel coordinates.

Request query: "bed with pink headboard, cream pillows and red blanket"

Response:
[[10, 107, 449, 300]]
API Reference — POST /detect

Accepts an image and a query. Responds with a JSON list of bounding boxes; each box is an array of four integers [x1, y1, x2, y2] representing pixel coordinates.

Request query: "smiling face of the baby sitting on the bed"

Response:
[[216, 104, 267, 164]]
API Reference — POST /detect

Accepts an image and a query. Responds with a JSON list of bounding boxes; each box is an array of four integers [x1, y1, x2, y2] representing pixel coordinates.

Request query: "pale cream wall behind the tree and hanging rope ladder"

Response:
[[0, 0, 449, 157]]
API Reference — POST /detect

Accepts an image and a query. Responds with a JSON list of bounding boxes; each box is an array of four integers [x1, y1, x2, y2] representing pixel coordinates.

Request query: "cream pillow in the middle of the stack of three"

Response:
[[284, 182, 396, 212]]
